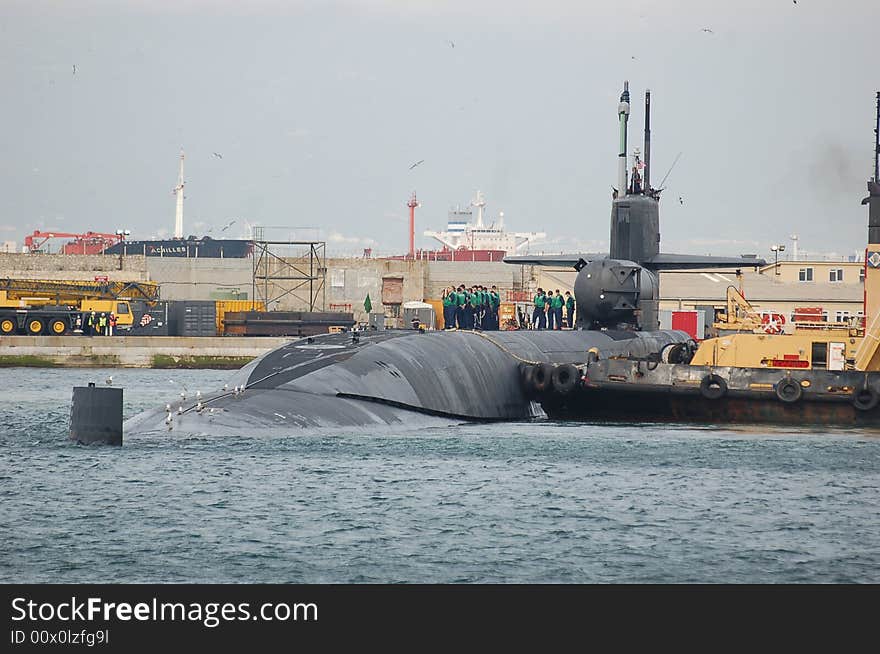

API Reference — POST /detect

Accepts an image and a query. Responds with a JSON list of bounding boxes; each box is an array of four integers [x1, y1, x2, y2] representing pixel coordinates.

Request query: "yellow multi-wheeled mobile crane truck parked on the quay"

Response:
[[0, 278, 159, 336]]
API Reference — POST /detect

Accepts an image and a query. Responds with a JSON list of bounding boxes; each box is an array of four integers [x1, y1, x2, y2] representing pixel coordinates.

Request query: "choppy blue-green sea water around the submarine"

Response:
[[0, 368, 880, 584]]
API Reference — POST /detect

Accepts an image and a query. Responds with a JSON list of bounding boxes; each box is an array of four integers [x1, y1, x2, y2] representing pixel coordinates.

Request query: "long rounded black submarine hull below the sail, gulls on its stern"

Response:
[[124, 330, 690, 436]]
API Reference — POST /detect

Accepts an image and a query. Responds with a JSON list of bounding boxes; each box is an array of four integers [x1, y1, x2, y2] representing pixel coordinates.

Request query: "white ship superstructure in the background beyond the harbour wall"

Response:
[[425, 191, 547, 255]]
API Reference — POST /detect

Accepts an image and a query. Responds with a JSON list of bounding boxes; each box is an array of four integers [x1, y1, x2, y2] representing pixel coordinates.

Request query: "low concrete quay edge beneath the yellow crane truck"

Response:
[[0, 336, 293, 369]]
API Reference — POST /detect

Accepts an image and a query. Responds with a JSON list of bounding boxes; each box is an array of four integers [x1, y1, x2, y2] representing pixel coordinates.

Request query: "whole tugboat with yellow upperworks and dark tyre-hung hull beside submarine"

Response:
[[520, 92, 880, 427]]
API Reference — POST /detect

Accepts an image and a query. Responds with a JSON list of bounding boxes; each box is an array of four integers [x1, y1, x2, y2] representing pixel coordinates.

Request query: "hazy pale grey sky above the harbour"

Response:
[[0, 0, 880, 258]]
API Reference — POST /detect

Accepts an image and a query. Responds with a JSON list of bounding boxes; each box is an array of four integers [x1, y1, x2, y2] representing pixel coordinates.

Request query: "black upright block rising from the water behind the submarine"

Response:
[[70, 382, 122, 445]]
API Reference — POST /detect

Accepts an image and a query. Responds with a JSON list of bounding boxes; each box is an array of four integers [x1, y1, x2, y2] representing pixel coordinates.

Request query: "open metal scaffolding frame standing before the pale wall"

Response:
[[251, 226, 327, 311]]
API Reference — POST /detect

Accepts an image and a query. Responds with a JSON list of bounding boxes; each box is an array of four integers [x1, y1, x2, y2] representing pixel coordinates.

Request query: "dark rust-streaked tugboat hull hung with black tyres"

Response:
[[526, 359, 880, 427]]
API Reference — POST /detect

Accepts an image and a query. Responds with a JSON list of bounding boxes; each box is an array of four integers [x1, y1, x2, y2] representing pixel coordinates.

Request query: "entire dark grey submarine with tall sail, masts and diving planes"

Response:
[[123, 82, 765, 436]]
